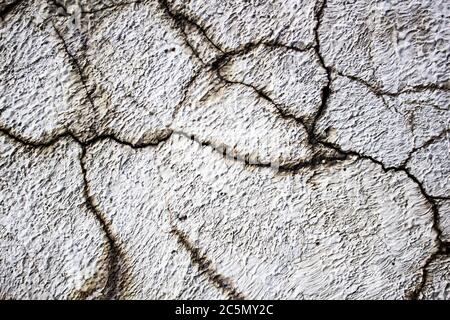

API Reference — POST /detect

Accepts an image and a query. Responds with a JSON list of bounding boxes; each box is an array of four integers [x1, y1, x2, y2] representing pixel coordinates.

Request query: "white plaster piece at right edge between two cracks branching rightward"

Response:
[[316, 76, 450, 167]]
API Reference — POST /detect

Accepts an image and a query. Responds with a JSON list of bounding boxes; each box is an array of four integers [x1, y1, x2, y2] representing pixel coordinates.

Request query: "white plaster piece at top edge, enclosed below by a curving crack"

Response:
[[167, 0, 315, 51]]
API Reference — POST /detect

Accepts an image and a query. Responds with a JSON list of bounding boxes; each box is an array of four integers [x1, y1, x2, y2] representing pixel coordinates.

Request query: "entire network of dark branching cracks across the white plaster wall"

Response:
[[0, 0, 450, 299]]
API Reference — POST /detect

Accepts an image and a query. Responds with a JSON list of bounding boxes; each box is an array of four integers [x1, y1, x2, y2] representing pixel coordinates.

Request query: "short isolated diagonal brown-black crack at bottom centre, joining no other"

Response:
[[167, 209, 245, 300]]
